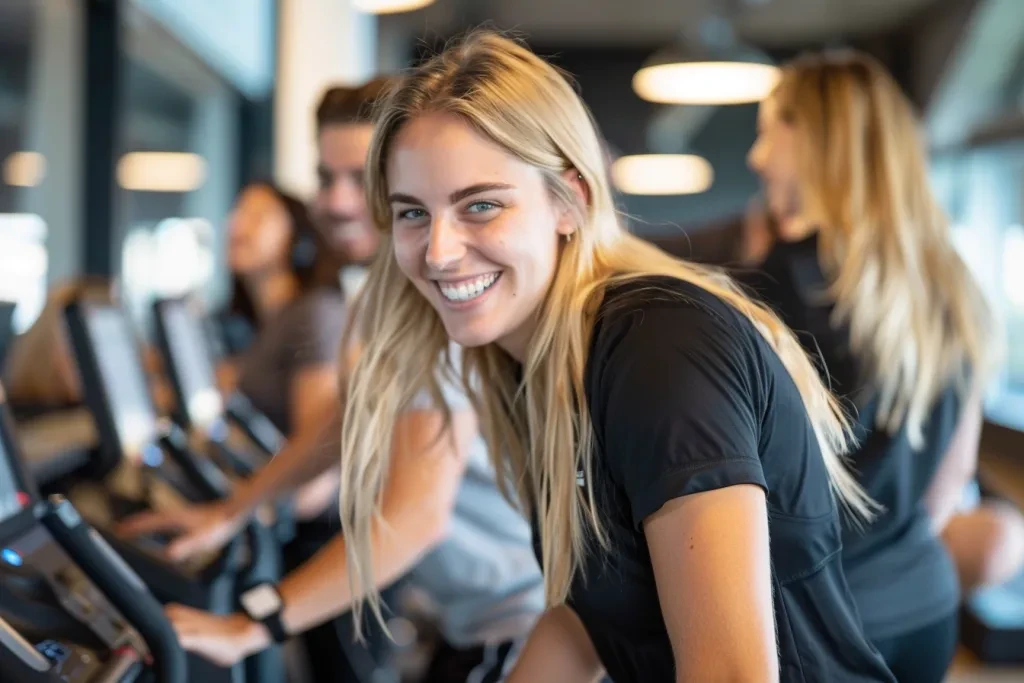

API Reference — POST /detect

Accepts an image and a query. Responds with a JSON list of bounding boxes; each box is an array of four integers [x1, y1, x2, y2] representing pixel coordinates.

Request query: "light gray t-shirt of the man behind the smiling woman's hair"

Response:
[[412, 346, 544, 647]]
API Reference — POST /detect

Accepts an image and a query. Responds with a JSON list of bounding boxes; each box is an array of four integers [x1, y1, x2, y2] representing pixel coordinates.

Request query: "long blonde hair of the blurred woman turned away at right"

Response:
[[771, 50, 998, 447]]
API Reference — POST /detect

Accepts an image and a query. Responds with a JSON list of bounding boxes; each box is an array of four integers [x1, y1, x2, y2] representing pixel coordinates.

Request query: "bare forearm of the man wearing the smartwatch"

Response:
[[281, 499, 445, 634]]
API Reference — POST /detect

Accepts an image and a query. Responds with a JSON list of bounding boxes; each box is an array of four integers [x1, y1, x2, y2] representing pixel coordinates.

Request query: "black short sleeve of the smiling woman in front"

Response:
[[592, 304, 767, 529]]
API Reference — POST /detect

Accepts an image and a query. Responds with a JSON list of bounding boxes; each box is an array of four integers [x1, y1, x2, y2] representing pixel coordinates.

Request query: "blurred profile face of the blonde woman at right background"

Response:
[[746, 97, 800, 232]]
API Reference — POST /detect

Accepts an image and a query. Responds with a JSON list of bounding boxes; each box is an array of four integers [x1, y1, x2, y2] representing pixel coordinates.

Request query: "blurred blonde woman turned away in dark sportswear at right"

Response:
[[750, 51, 998, 683]]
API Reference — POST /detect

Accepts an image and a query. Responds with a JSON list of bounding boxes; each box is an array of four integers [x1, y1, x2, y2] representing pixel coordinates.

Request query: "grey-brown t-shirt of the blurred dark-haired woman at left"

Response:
[[239, 288, 345, 436]]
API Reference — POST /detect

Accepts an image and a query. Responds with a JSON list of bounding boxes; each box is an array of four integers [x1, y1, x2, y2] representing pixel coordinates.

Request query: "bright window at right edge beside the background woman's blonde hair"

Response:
[[936, 142, 1024, 430]]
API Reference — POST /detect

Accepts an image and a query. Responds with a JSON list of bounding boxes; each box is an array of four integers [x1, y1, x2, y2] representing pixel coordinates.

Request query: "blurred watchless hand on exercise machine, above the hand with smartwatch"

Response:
[[118, 501, 246, 562]]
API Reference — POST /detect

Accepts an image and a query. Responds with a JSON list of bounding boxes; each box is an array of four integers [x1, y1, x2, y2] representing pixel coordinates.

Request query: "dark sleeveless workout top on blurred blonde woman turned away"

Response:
[[739, 237, 961, 639]]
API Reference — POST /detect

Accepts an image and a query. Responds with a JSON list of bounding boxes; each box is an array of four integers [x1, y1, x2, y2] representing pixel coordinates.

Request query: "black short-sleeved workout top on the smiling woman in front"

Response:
[[544, 278, 893, 683]]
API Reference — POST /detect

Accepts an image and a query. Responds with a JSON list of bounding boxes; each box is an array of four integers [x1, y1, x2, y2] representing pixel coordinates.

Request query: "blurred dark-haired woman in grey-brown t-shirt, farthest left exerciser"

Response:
[[218, 182, 345, 516]]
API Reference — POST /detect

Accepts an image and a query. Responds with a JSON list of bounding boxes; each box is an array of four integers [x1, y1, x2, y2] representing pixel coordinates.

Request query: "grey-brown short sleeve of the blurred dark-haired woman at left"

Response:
[[278, 290, 346, 372]]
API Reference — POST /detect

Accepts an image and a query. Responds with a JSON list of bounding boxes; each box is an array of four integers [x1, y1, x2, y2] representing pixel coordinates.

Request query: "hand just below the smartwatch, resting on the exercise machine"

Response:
[[164, 604, 270, 667]]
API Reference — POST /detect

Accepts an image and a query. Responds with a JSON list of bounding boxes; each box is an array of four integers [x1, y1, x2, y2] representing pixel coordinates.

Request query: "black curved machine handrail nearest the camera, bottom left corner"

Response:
[[39, 496, 188, 683]]
